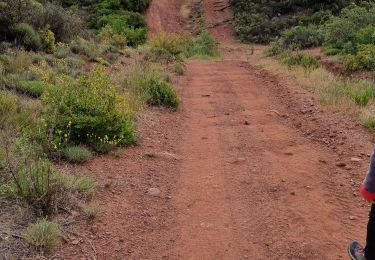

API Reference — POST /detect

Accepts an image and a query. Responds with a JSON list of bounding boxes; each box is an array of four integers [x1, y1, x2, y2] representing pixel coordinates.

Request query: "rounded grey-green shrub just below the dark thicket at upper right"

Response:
[[281, 25, 324, 49]]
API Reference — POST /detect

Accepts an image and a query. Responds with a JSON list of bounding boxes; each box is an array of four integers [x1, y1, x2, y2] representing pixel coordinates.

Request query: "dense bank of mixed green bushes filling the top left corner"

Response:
[[0, 0, 149, 52]]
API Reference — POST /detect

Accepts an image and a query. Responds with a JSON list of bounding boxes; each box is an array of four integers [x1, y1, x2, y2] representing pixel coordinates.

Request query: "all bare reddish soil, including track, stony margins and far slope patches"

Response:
[[55, 0, 371, 259]]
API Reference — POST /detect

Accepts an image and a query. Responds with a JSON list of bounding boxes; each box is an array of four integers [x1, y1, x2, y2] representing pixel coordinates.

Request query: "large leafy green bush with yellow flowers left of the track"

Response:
[[43, 69, 136, 152]]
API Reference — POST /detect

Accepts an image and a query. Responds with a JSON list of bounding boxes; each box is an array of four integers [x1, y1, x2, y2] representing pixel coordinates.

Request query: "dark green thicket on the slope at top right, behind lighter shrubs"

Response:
[[231, 0, 374, 43]]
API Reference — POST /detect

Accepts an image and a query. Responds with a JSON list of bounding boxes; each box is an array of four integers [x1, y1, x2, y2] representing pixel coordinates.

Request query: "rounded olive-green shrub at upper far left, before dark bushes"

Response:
[[11, 23, 41, 50]]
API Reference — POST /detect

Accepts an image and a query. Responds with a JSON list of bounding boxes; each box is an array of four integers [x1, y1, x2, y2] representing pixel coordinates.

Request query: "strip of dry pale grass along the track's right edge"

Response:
[[257, 51, 375, 131]]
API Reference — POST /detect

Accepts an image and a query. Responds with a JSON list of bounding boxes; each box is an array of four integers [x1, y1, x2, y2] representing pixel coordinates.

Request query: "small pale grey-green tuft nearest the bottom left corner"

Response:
[[24, 218, 61, 250]]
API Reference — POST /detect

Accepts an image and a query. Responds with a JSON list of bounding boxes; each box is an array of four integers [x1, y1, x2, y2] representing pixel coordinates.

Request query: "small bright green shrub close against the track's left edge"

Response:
[[147, 80, 180, 109]]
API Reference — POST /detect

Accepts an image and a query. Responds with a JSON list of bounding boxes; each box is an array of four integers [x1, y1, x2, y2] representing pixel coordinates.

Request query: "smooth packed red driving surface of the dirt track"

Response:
[[173, 60, 365, 259]]
